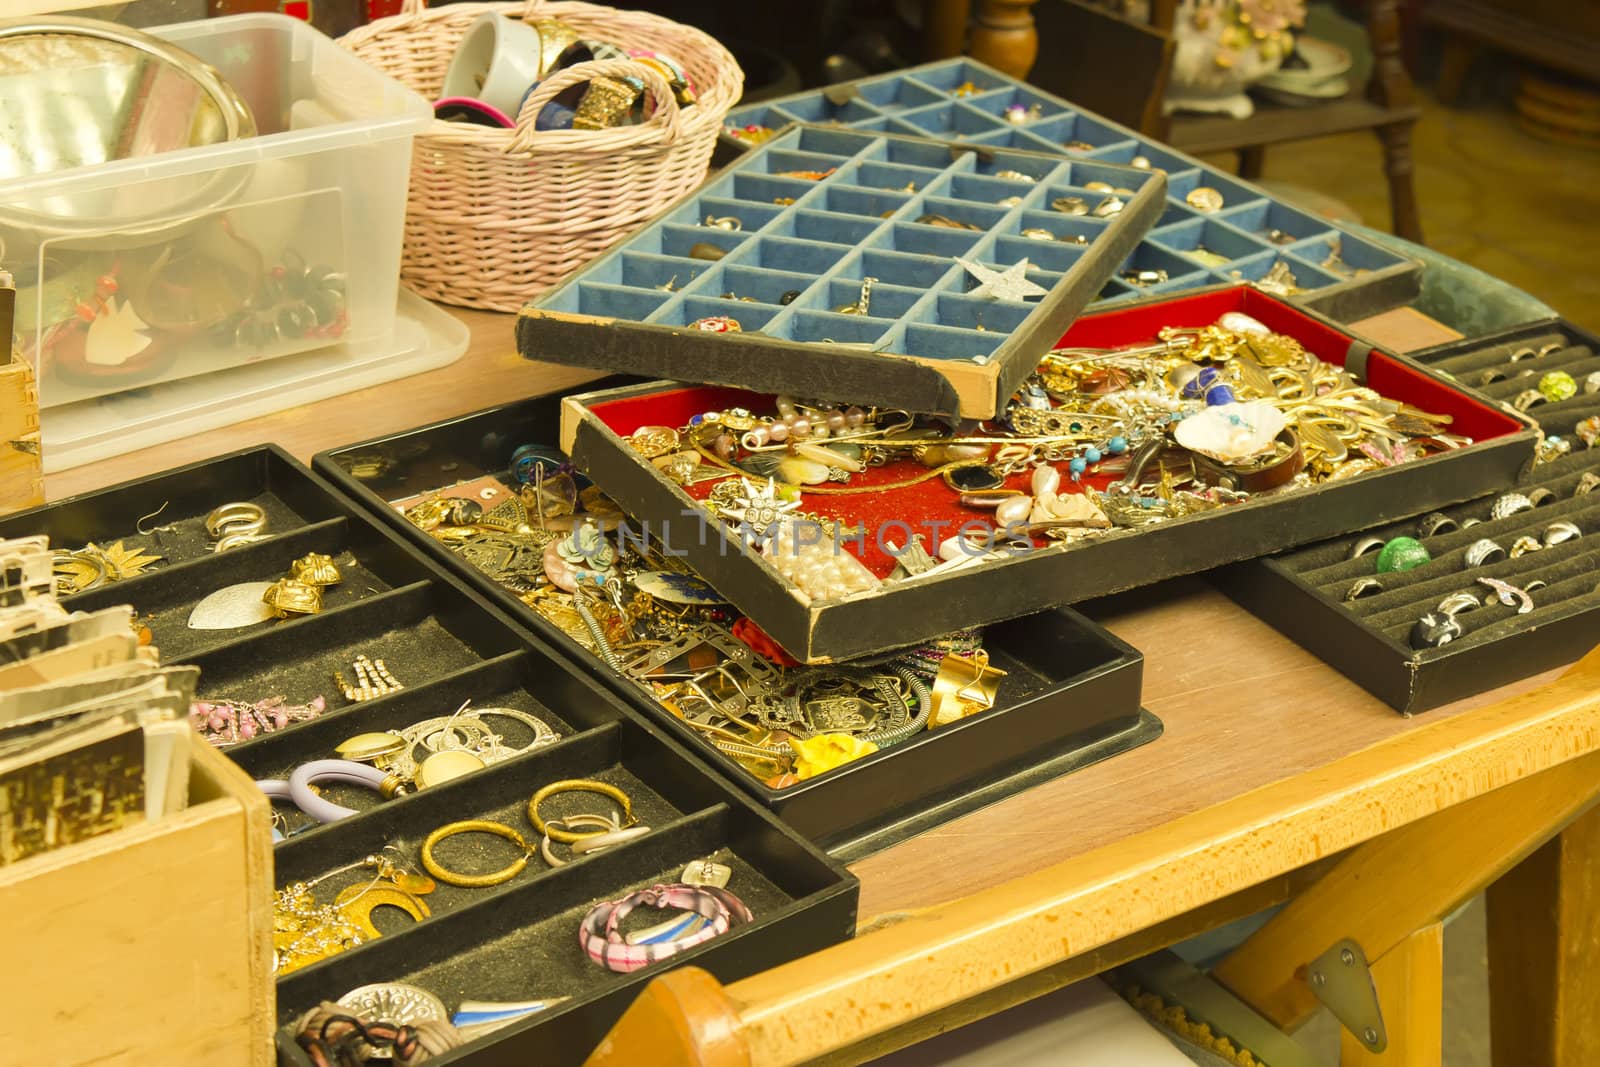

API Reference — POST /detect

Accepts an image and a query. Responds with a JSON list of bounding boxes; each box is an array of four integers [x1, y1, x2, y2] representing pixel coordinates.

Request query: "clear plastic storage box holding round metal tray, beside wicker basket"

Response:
[[0, 14, 459, 469]]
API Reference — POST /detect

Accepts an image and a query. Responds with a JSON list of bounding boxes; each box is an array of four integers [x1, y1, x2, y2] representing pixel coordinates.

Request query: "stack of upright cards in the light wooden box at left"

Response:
[[0, 537, 200, 867]]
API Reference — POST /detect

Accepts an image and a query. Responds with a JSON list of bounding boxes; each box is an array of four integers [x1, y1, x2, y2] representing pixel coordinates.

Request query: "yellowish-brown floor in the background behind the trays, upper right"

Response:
[[1210, 88, 1600, 330]]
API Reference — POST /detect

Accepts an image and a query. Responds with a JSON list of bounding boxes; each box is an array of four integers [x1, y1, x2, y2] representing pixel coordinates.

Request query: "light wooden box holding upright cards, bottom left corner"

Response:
[[0, 741, 274, 1067]]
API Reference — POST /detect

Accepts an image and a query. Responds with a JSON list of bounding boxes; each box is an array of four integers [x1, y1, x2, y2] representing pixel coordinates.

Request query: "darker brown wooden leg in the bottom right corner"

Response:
[[1488, 808, 1600, 1067]]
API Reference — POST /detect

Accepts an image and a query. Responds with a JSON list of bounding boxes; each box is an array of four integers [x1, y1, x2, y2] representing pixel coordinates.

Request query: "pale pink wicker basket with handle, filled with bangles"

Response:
[[339, 0, 744, 312]]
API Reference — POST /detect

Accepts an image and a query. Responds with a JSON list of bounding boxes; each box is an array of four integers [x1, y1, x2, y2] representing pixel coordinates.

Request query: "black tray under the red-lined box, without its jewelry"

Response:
[[312, 391, 1160, 859]]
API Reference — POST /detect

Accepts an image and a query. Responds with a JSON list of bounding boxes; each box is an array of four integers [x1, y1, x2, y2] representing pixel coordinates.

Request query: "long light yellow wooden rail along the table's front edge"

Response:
[[726, 653, 1600, 1067]]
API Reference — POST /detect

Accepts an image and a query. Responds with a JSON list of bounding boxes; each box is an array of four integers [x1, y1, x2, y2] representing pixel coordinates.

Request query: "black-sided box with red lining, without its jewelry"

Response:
[[562, 286, 1536, 662]]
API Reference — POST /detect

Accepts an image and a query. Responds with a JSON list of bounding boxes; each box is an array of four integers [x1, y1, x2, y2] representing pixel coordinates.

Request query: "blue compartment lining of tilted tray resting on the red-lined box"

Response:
[[539, 126, 1170, 360]]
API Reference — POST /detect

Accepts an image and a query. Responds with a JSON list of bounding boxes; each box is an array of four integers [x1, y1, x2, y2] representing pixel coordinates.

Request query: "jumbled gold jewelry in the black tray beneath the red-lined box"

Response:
[[392, 447, 1005, 789]]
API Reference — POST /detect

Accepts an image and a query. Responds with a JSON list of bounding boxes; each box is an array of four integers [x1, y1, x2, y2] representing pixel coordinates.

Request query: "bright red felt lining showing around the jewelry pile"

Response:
[[590, 286, 1525, 577]]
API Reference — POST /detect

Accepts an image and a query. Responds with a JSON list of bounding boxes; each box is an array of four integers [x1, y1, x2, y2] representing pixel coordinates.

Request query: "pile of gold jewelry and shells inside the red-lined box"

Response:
[[675, 312, 1470, 559]]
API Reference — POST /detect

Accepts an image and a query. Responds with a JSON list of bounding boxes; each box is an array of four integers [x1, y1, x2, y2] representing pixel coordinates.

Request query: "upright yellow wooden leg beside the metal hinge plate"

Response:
[[1339, 923, 1445, 1067]]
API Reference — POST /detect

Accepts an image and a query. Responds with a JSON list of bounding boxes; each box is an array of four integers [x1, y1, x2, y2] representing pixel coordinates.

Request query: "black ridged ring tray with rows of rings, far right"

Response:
[[1214, 320, 1600, 713]]
